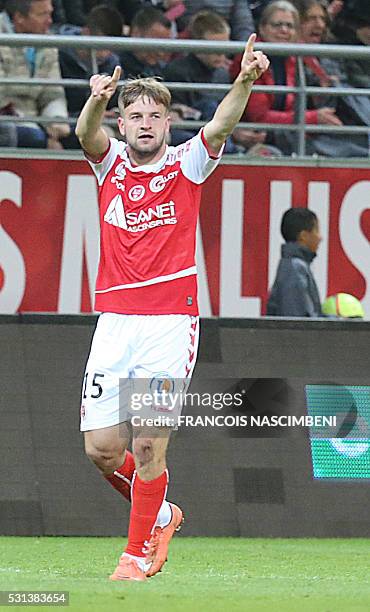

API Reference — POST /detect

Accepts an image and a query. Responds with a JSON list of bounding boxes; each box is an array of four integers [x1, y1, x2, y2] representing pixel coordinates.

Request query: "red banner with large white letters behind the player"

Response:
[[0, 159, 370, 317]]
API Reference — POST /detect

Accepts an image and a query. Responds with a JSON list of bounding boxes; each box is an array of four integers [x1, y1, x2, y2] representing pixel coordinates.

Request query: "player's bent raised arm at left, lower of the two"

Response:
[[76, 66, 121, 160]]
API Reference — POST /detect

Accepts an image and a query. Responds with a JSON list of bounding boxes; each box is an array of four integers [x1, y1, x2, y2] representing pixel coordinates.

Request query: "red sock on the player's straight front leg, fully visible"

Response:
[[126, 470, 168, 557]]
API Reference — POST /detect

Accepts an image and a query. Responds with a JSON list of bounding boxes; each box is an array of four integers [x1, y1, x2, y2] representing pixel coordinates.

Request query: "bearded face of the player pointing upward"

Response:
[[118, 98, 170, 164]]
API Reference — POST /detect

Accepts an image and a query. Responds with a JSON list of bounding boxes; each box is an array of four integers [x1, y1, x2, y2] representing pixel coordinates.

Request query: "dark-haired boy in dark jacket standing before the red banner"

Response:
[[266, 208, 323, 317]]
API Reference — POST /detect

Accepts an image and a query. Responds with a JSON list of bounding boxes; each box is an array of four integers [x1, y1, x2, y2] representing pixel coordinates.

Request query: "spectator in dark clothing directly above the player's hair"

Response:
[[120, 6, 171, 78]]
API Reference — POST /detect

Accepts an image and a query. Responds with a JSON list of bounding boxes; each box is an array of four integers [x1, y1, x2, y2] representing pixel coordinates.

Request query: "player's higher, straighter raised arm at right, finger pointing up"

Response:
[[204, 34, 270, 151]]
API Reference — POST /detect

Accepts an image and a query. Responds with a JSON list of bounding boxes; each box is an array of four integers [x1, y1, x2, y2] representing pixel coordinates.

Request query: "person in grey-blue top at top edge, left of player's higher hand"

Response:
[[183, 0, 255, 41]]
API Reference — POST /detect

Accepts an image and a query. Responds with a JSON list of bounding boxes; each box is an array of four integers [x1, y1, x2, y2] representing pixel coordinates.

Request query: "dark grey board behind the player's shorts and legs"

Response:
[[0, 315, 370, 537]]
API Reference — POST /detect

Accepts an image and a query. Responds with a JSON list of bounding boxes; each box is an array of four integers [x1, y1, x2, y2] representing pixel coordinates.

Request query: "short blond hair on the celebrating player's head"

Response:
[[118, 77, 171, 115]]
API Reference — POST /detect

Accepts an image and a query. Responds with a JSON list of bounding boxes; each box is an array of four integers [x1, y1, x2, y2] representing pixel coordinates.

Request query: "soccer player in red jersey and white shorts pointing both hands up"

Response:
[[76, 34, 269, 580]]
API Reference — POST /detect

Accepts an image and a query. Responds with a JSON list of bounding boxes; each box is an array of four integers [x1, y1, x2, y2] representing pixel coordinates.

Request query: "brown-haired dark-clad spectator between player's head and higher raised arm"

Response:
[[163, 11, 264, 153]]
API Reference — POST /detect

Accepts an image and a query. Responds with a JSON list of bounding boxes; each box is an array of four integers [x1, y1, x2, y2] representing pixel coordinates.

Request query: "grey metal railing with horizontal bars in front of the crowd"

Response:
[[0, 34, 370, 157]]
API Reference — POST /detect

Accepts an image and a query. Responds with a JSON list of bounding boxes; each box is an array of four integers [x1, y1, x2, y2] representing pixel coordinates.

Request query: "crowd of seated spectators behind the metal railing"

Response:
[[0, 0, 370, 157]]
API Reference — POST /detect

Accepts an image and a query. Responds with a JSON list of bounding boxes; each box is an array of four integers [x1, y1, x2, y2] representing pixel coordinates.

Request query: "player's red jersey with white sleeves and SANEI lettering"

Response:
[[88, 130, 222, 315]]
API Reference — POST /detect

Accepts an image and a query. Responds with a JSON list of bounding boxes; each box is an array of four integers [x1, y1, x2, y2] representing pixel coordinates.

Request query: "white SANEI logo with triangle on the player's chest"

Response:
[[104, 194, 177, 232]]
